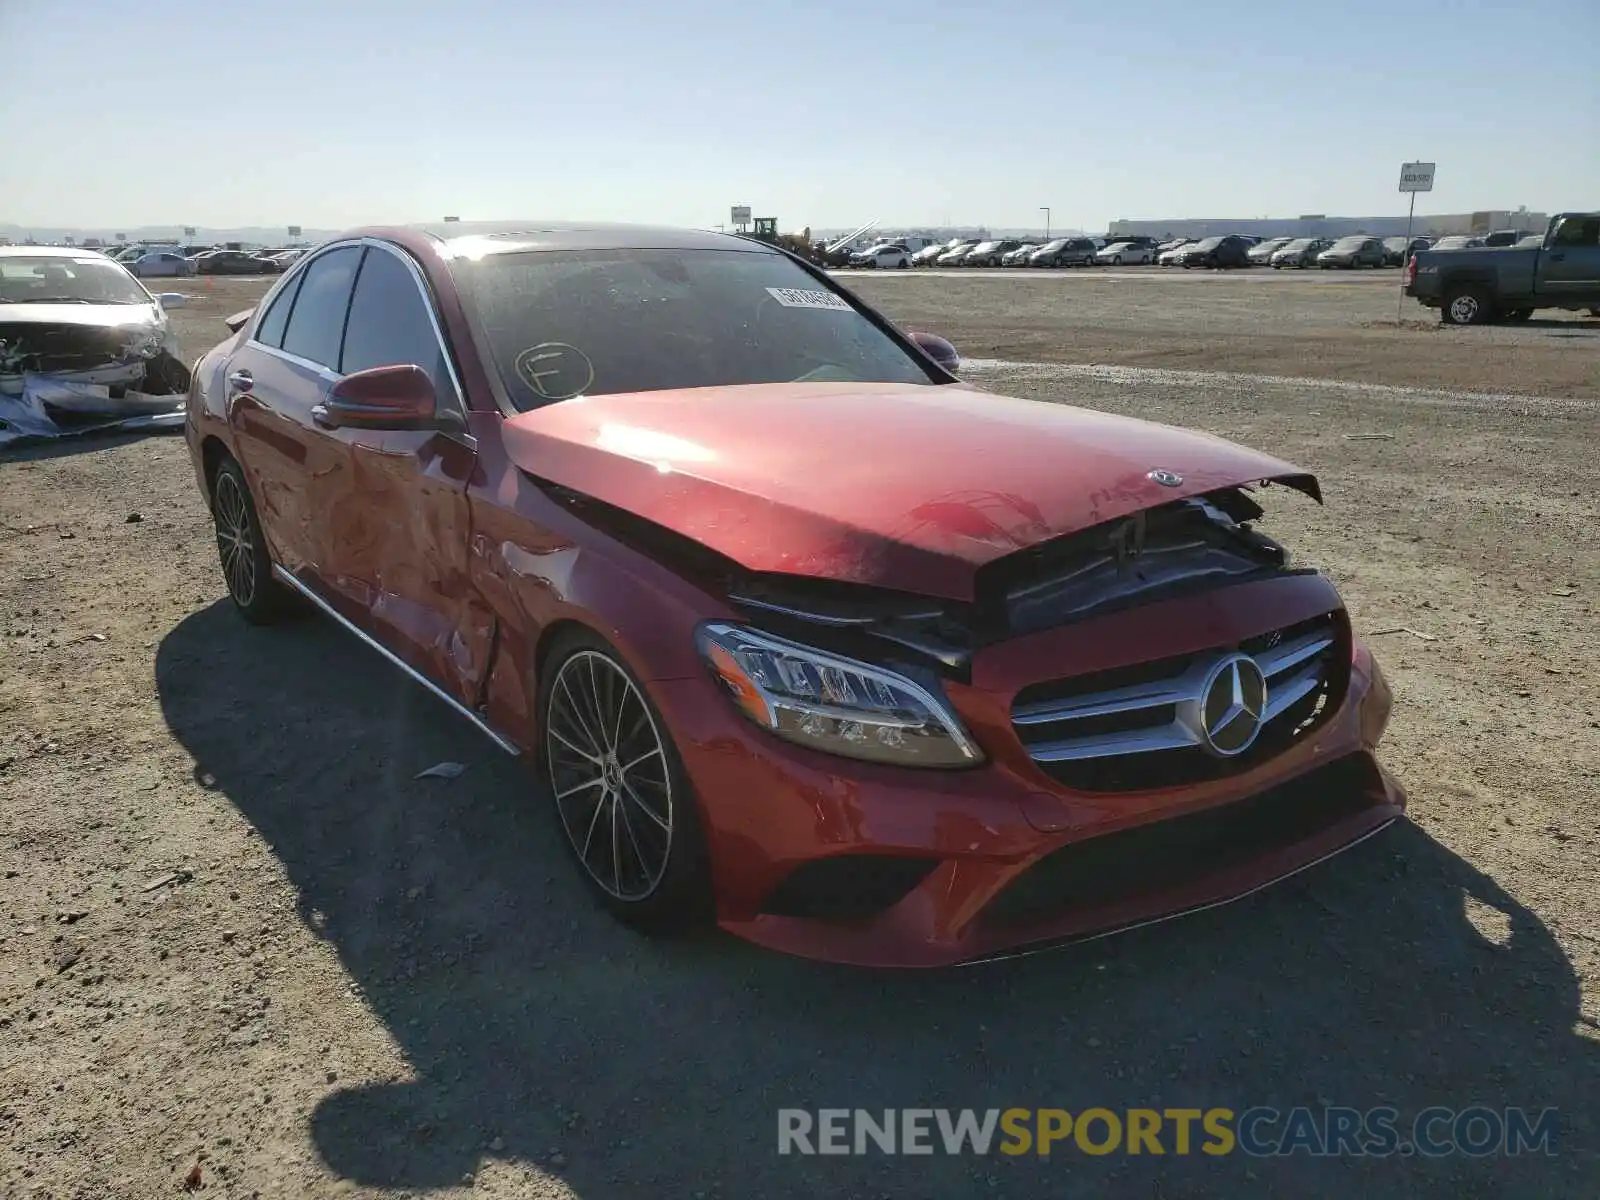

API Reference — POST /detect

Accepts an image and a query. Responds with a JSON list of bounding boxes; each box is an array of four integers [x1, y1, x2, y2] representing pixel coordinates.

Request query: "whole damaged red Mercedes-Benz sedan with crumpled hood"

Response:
[[187, 222, 1405, 966]]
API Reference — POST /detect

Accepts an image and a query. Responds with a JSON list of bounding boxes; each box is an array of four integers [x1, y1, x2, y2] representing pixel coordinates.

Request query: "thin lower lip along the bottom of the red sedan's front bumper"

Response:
[[718, 764, 1406, 968]]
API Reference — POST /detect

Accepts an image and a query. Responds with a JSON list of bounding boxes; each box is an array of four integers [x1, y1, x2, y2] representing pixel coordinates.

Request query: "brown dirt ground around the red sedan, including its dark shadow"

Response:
[[0, 272, 1600, 1200]]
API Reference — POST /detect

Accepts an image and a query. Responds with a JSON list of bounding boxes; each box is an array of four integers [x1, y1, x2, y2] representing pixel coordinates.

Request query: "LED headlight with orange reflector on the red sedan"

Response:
[[696, 622, 984, 766]]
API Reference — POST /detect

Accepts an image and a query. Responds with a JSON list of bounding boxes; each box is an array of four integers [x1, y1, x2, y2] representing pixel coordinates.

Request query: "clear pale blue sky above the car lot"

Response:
[[0, 0, 1600, 230]]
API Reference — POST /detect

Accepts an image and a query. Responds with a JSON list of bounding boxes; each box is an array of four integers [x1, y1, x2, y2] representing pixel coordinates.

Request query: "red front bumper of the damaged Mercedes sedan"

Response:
[[651, 582, 1406, 966]]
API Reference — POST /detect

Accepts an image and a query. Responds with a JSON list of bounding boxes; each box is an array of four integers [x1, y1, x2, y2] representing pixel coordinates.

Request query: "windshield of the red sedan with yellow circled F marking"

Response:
[[453, 250, 936, 410]]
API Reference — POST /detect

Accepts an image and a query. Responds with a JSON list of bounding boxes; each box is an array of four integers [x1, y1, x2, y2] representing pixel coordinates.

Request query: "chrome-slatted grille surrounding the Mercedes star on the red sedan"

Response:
[[1011, 613, 1349, 792]]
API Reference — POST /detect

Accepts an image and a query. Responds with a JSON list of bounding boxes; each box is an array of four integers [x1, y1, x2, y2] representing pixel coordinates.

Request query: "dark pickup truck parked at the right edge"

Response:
[[1405, 213, 1600, 325]]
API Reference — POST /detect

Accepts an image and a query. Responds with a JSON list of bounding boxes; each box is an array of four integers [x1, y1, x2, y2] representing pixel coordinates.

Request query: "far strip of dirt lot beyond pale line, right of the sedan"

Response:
[[848, 267, 1600, 398]]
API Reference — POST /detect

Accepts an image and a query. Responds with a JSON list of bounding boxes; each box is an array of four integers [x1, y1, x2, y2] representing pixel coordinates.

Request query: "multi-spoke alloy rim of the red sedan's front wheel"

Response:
[[544, 650, 674, 902]]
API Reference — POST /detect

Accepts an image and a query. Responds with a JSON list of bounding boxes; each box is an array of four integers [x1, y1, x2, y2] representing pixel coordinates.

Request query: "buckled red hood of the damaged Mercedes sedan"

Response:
[[504, 384, 1320, 600]]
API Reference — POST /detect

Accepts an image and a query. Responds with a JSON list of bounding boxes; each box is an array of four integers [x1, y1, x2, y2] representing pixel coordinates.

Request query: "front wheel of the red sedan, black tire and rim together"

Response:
[[539, 629, 714, 933]]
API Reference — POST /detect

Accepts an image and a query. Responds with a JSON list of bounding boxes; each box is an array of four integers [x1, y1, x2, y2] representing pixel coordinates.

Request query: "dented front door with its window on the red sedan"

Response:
[[322, 243, 494, 707]]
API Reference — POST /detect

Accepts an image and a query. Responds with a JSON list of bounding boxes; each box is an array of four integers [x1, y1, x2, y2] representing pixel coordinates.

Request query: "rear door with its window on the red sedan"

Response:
[[224, 243, 365, 621]]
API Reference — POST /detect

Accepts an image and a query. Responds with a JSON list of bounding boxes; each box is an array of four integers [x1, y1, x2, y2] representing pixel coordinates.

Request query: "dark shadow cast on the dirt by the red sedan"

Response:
[[157, 602, 1600, 1200]]
